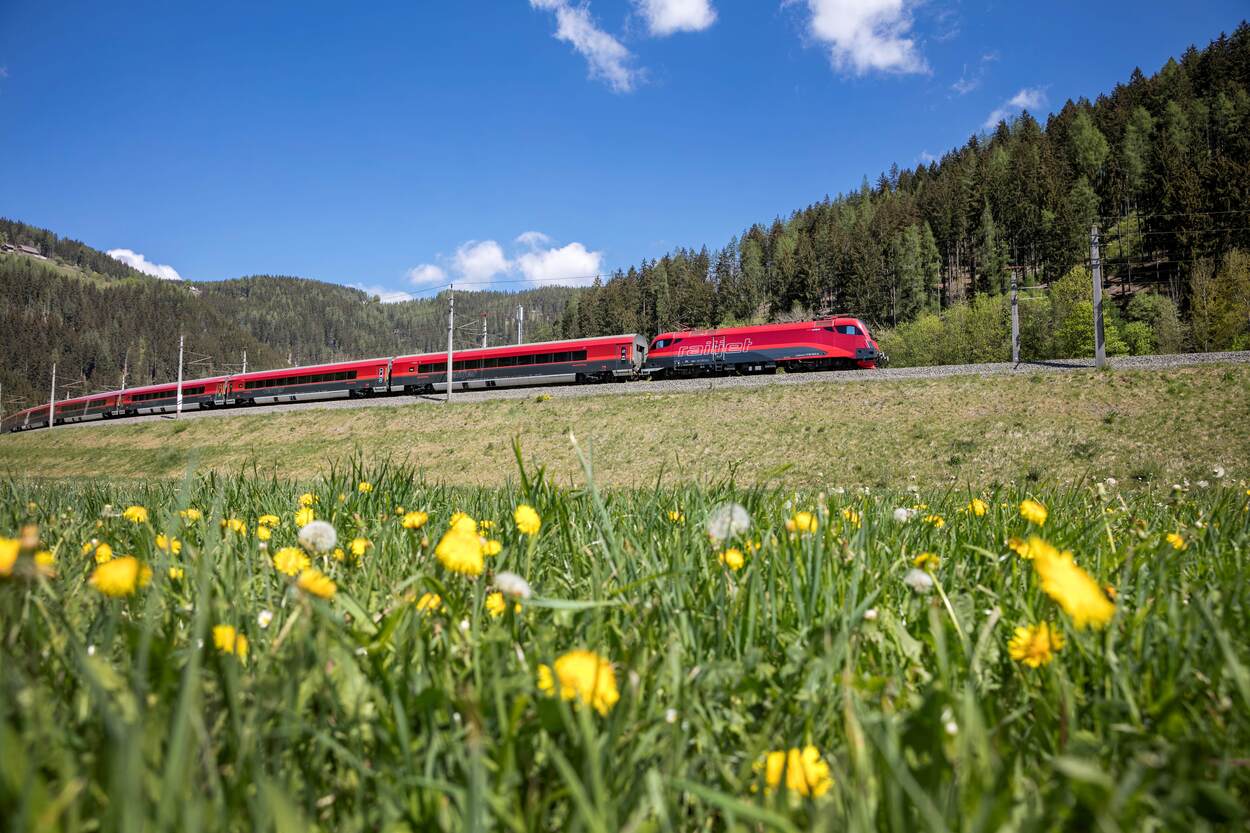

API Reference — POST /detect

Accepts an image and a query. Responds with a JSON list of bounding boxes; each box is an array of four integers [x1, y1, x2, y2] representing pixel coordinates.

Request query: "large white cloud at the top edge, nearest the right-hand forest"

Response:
[[808, 0, 929, 75]]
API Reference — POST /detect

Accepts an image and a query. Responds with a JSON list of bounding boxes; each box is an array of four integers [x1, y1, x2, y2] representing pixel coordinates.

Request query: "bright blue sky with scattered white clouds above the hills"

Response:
[[0, 0, 1246, 298]]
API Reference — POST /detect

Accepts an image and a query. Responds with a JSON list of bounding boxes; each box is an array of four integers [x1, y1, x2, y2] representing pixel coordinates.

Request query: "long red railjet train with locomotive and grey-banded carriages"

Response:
[[0, 318, 884, 432]]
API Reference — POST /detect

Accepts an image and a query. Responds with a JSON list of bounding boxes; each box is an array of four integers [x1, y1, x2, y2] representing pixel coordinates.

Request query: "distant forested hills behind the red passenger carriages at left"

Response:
[[0, 220, 578, 413]]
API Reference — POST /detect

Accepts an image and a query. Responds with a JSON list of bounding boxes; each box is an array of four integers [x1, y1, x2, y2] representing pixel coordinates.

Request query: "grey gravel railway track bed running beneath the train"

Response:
[[53, 350, 1250, 430]]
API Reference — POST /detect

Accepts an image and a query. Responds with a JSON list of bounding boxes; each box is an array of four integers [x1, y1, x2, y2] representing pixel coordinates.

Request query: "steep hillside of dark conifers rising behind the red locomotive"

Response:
[[565, 23, 1250, 358]]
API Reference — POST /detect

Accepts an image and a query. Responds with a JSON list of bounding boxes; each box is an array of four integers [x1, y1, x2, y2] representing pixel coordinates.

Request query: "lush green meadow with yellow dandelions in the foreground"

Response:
[[0, 455, 1250, 833]]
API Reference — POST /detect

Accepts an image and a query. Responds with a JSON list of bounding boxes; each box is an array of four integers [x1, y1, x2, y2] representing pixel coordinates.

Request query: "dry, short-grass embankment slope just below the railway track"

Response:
[[0, 365, 1250, 488]]
